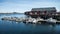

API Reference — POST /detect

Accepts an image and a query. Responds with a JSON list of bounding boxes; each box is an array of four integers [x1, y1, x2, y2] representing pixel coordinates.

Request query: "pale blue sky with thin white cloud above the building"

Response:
[[0, 0, 60, 13]]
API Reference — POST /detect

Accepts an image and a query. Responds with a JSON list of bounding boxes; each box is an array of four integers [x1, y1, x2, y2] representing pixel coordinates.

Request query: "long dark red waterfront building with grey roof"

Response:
[[25, 7, 60, 19]]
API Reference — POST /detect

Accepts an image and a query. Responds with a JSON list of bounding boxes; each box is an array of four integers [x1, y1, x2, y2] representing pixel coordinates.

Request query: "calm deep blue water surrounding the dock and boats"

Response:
[[0, 14, 60, 34]]
